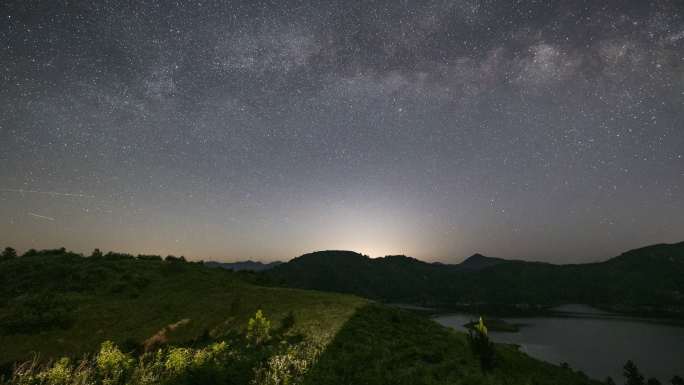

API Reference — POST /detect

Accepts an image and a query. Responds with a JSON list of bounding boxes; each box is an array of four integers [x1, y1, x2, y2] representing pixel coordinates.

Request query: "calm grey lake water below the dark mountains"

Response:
[[435, 305, 684, 384]]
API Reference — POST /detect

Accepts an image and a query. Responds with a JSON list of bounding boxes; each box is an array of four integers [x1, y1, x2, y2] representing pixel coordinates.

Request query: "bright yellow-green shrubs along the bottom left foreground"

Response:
[[0, 311, 318, 385]]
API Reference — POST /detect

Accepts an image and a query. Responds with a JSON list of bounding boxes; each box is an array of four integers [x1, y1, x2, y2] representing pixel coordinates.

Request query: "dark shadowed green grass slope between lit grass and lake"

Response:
[[304, 304, 597, 385]]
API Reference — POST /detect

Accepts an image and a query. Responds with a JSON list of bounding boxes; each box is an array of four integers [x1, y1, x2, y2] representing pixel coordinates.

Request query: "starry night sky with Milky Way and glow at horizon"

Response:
[[0, 0, 684, 263]]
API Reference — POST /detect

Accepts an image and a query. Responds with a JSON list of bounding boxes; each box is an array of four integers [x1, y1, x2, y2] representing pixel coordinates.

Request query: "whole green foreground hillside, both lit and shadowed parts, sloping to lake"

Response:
[[0, 250, 592, 385]]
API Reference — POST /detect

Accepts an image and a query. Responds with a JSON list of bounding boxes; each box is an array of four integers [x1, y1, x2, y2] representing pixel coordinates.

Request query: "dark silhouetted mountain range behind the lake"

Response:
[[265, 242, 684, 315]]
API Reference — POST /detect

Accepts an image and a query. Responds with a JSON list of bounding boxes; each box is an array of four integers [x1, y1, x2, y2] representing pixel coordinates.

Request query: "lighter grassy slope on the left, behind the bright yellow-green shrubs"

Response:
[[0, 255, 366, 367]]
